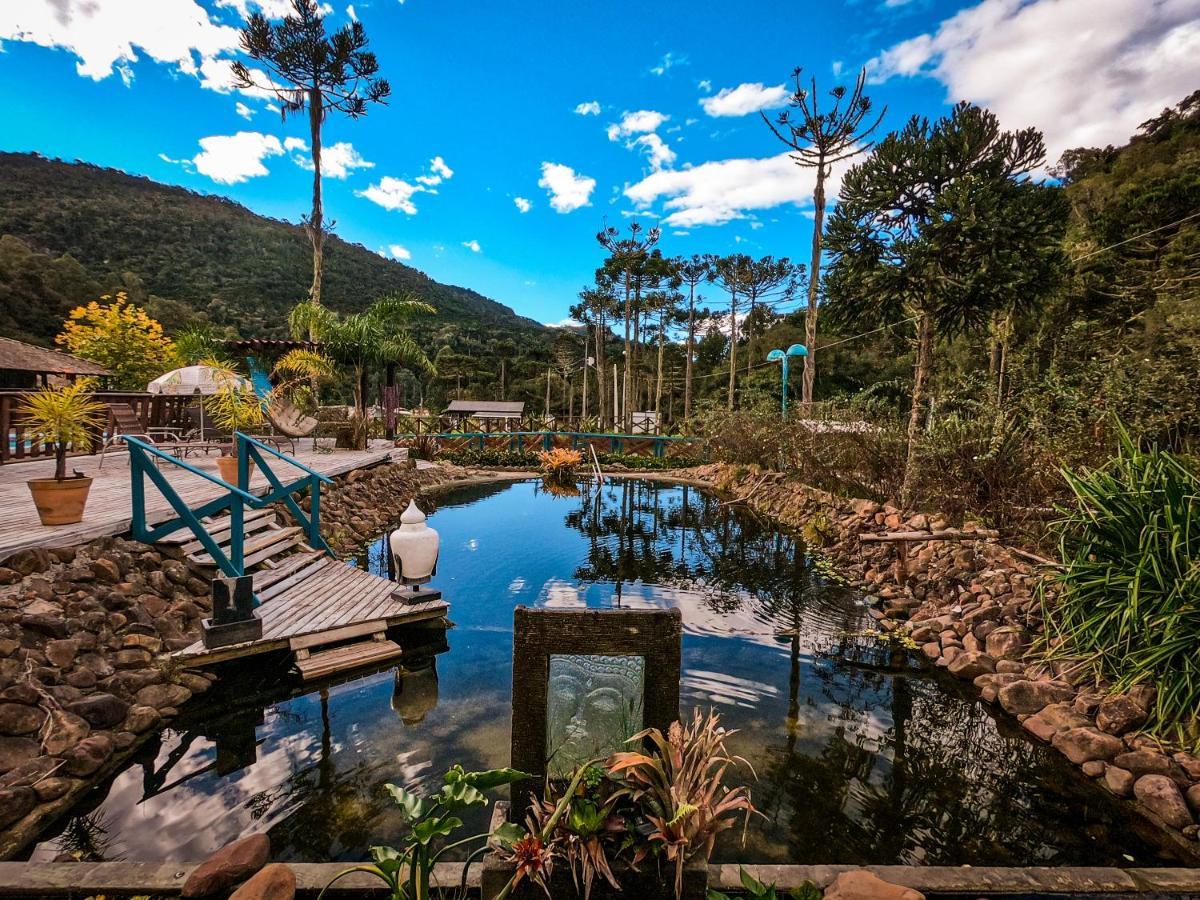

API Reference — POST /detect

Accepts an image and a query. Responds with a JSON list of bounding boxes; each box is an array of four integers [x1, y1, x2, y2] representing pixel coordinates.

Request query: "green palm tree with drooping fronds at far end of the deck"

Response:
[[281, 296, 437, 450]]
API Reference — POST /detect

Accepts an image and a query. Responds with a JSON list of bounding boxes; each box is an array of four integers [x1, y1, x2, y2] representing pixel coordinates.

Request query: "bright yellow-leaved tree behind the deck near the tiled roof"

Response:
[[55, 290, 175, 391]]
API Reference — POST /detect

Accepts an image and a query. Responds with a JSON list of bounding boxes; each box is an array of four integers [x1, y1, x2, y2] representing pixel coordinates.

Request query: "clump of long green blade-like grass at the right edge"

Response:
[[1045, 428, 1200, 746]]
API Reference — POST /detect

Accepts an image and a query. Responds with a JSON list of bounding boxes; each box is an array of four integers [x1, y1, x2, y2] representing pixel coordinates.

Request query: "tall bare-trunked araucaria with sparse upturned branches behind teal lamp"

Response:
[[761, 68, 887, 403]]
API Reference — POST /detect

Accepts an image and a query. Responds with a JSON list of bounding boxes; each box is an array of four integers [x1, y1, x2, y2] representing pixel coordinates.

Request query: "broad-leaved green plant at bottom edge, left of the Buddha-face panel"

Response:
[[318, 766, 530, 900]]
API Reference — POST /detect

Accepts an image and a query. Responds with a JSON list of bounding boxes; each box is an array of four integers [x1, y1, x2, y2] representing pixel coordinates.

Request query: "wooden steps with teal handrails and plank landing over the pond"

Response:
[[126, 433, 449, 679]]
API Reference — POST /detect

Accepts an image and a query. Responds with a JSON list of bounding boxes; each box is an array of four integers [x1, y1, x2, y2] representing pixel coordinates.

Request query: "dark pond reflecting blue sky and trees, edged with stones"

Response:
[[25, 481, 1162, 865]]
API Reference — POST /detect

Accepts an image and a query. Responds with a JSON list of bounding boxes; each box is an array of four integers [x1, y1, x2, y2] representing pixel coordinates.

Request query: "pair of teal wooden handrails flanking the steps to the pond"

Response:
[[124, 432, 334, 577]]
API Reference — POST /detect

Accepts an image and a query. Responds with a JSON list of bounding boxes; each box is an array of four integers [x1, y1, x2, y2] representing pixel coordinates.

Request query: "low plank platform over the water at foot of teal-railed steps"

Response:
[[172, 558, 450, 666]]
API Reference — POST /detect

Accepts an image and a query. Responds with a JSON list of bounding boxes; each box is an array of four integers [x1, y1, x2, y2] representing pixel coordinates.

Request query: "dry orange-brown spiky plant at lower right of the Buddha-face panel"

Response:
[[607, 709, 755, 895]]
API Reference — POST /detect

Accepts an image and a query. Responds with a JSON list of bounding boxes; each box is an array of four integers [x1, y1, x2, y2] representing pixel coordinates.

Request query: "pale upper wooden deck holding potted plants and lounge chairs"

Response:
[[0, 439, 404, 559]]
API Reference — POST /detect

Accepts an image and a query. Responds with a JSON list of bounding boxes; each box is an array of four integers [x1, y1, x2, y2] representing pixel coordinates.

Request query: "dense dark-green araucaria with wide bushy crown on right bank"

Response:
[[827, 103, 1068, 504]]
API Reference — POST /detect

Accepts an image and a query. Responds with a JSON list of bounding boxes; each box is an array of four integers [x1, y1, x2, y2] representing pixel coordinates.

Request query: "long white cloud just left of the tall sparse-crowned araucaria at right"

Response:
[[625, 152, 848, 228]]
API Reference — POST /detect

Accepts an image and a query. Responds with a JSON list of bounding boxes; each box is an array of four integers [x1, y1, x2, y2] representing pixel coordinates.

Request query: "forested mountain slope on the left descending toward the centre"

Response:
[[0, 152, 542, 343]]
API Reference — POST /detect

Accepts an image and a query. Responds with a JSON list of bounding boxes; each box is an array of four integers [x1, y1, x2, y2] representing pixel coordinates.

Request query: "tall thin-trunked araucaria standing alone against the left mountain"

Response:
[[233, 0, 391, 304]]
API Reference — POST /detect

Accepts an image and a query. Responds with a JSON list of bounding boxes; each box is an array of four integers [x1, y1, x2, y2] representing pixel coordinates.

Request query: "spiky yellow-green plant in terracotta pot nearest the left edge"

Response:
[[22, 379, 104, 526]]
